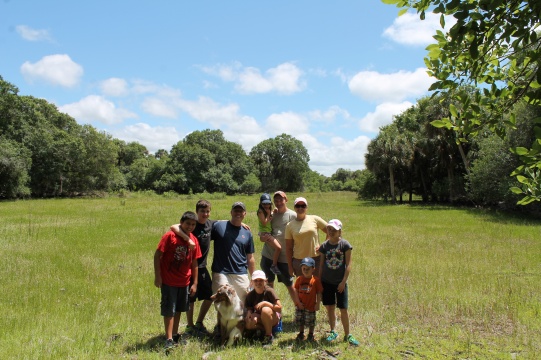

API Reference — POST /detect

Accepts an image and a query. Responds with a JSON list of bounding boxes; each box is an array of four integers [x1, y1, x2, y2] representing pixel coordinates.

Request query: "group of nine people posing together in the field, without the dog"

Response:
[[154, 191, 359, 348]]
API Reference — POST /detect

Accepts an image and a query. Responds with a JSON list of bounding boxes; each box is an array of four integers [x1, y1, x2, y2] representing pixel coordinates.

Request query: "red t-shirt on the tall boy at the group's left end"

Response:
[[158, 231, 201, 287]]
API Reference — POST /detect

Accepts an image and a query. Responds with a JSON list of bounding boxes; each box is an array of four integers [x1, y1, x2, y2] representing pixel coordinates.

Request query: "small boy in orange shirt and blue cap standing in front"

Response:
[[293, 257, 323, 341]]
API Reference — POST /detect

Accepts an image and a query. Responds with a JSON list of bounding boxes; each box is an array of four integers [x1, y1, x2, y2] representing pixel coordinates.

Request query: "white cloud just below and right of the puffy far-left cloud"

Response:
[[59, 95, 137, 124]]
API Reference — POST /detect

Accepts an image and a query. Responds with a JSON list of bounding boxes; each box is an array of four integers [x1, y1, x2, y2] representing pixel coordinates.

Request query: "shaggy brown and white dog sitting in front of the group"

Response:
[[210, 284, 244, 346]]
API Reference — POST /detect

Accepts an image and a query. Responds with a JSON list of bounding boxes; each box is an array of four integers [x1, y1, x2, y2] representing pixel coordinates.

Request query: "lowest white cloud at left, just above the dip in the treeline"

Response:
[[111, 123, 183, 153]]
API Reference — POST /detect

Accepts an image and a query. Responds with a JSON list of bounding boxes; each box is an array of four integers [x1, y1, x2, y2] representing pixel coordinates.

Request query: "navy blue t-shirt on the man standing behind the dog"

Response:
[[211, 221, 255, 275]]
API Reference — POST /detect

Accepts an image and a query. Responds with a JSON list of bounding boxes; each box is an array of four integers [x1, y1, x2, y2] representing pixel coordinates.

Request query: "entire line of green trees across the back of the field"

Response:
[[0, 76, 541, 209]]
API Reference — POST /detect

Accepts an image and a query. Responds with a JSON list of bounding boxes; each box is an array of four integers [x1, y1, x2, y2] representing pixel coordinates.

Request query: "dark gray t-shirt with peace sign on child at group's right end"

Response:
[[319, 239, 353, 285]]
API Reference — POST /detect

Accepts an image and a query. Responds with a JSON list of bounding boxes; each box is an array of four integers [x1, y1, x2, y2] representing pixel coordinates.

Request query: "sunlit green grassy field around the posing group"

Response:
[[0, 193, 541, 359]]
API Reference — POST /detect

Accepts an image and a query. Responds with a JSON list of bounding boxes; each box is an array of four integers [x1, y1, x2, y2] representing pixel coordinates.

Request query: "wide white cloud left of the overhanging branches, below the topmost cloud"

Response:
[[348, 68, 434, 102]]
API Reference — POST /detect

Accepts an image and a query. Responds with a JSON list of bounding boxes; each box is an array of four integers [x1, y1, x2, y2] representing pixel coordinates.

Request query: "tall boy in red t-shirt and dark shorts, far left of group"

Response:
[[154, 211, 201, 349]]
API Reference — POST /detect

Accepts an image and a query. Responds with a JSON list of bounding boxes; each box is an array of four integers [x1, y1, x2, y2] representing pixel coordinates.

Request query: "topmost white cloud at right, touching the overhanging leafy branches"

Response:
[[383, 12, 456, 46]]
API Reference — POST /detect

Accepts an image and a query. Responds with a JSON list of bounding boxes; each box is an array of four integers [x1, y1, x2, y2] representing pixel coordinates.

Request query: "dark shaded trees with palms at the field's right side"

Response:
[[358, 95, 541, 209]]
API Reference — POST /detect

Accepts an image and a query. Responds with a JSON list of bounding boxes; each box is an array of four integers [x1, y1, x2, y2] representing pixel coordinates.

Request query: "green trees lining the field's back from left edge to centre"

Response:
[[0, 77, 356, 199]]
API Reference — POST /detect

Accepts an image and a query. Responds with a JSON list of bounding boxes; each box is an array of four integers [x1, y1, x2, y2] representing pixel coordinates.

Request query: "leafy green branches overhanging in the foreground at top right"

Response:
[[384, 0, 541, 205]]
